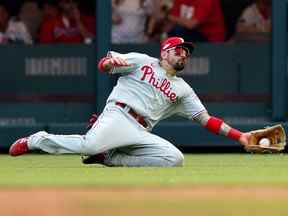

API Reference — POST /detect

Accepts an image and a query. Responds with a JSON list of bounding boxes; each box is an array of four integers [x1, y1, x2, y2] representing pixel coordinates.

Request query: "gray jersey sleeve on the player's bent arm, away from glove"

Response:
[[107, 51, 145, 74]]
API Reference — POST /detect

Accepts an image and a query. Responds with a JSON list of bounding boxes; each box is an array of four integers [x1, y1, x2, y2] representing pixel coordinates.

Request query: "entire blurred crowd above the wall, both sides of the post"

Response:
[[0, 0, 272, 44]]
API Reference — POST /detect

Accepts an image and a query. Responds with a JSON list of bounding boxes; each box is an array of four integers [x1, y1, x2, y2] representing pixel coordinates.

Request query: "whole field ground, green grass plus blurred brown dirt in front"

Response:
[[0, 154, 288, 216]]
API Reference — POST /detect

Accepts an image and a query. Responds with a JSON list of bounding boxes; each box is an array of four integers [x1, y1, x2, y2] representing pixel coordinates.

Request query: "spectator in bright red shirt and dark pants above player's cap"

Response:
[[168, 0, 226, 42]]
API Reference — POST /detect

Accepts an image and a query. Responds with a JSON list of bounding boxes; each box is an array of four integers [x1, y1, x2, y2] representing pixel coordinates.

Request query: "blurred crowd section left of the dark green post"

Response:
[[0, 0, 96, 44]]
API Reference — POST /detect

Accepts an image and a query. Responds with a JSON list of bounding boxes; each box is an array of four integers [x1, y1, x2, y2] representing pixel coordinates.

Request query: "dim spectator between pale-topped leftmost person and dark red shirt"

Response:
[[19, 0, 42, 41]]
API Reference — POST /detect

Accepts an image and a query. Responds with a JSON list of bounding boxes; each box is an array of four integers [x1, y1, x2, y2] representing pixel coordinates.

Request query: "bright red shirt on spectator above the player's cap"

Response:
[[171, 0, 226, 42]]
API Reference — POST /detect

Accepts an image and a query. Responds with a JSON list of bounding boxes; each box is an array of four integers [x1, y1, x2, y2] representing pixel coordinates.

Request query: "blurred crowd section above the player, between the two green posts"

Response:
[[112, 0, 271, 43]]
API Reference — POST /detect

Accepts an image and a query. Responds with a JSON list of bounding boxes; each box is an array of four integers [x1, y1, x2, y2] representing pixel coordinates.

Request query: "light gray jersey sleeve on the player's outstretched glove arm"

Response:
[[177, 88, 206, 119]]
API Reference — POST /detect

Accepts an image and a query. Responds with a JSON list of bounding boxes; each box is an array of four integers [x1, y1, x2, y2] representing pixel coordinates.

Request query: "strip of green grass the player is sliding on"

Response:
[[0, 154, 288, 188]]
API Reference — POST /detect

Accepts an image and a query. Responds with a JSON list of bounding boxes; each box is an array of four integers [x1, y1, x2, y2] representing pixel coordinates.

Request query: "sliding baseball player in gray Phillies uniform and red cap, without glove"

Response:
[[9, 37, 251, 167]]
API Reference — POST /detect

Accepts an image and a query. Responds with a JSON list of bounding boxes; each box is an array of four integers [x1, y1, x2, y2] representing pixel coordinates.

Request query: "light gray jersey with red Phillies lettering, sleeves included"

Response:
[[107, 52, 206, 128]]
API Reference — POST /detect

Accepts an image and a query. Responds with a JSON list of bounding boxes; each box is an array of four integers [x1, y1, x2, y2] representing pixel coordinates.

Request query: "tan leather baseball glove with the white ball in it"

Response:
[[245, 124, 286, 153]]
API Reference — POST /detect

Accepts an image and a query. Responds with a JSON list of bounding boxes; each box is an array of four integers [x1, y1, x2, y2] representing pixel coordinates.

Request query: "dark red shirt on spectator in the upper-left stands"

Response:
[[39, 16, 95, 43]]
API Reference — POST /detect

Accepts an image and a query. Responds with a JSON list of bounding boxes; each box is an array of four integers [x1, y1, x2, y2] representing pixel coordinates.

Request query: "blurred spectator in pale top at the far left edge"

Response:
[[0, 3, 32, 44]]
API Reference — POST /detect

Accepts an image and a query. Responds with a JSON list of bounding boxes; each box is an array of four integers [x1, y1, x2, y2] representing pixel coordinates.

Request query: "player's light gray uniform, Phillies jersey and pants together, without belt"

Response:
[[28, 52, 206, 166]]
